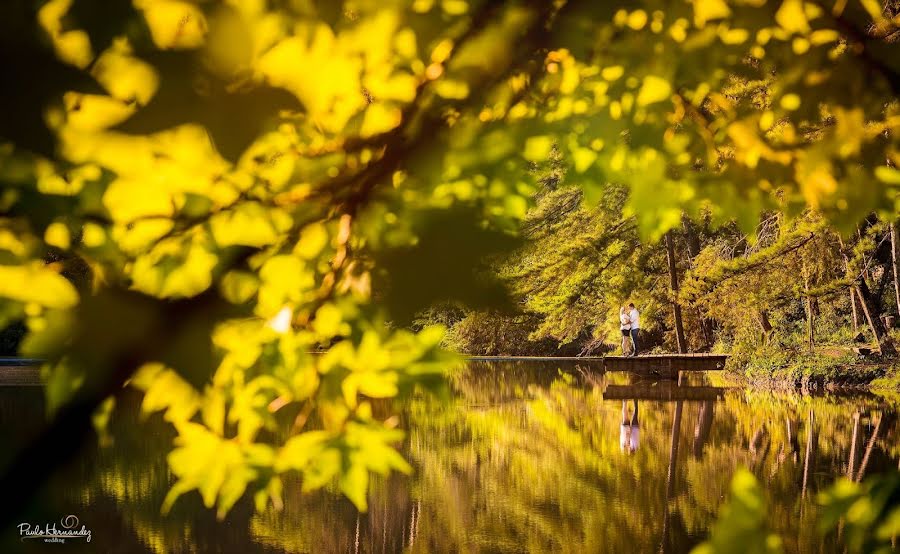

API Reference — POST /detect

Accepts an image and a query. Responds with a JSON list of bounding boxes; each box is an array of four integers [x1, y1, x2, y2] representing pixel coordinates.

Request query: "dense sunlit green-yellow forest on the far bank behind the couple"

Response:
[[418, 171, 900, 381]]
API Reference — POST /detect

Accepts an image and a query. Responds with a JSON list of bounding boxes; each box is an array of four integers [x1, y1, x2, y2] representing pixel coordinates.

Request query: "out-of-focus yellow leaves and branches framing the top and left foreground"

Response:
[[0, 0, 900, 517]]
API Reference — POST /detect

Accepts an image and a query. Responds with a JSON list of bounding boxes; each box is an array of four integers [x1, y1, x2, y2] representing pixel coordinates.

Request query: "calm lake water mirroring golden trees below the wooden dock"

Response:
[[0, 362, 900, 553]]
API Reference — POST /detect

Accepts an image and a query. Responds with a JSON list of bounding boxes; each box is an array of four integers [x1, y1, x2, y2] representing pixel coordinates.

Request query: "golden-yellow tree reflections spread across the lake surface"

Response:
[[89, 364, 892, 552]]
